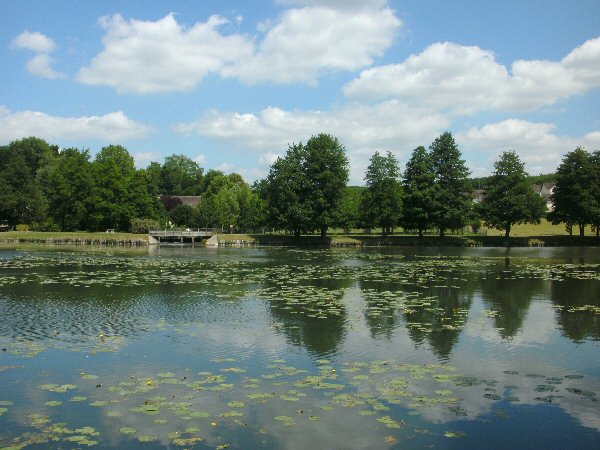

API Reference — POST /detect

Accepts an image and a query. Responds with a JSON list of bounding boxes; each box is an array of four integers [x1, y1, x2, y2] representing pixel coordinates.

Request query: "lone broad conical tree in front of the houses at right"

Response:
[[479, 151, 546, 238]]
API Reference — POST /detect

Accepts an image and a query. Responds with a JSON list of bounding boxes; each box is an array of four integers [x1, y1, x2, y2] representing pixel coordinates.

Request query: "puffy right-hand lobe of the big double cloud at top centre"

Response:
[[222, 6, 401, 84]]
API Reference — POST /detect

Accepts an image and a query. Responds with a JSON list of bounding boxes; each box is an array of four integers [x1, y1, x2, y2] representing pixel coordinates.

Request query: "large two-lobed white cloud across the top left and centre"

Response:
[[77, 2, 401, 94]]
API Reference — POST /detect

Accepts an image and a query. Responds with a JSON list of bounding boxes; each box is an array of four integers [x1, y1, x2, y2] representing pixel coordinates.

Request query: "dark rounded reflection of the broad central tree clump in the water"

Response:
[[269, 279, 353, 357]]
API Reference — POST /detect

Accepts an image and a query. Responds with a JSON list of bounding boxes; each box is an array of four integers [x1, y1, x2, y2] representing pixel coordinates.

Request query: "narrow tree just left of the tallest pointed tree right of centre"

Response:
[[402, 146, 436, 237]]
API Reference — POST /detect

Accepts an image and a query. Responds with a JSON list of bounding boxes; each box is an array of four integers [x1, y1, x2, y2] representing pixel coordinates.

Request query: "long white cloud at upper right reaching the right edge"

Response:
[[344, 38, 600, 115]]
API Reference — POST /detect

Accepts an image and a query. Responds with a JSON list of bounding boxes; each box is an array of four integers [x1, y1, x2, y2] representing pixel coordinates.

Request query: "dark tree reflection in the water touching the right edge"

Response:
[[550, 278, 600, 342]]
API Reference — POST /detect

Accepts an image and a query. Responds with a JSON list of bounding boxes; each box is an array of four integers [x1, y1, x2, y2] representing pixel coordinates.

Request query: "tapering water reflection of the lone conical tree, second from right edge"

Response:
[[480, 278, 547, 339]]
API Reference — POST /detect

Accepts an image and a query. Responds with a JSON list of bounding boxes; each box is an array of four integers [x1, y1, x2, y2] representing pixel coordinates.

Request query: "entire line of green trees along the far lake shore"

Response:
[[0, 132, 600, 236]]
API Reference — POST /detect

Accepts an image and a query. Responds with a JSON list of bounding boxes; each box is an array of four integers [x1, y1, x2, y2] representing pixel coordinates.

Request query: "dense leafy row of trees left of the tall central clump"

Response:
[[0, 137, 263, 231]]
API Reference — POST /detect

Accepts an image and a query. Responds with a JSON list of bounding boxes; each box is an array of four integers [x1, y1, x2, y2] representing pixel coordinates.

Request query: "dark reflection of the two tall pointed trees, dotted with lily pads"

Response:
[[404, 282, 474, 359]]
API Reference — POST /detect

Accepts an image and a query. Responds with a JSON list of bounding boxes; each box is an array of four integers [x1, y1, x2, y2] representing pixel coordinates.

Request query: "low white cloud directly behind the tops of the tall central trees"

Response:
[[174, 100, 449, 184]]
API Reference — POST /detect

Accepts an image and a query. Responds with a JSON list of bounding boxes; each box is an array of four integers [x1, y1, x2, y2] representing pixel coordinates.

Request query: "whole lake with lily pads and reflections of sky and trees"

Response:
[[0, 247, 600, 449]]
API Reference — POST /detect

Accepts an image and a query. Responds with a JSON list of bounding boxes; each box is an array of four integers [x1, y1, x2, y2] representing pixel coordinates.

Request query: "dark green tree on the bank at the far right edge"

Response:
[[548, 147, 598, 237]]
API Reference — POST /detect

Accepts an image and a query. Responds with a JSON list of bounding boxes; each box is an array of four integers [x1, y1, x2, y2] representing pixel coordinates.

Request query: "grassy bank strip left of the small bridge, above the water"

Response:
[[0, 231, 149, 245]]
